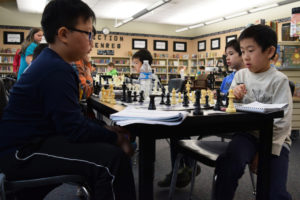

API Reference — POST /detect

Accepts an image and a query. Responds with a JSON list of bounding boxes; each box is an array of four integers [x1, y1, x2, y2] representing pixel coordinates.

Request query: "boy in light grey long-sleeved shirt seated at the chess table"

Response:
[[215, 25, 293, 200]]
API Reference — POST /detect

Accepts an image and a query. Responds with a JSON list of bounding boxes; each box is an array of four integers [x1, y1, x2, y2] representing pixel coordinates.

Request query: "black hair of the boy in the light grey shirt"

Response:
[[239, 24, 277, 59]]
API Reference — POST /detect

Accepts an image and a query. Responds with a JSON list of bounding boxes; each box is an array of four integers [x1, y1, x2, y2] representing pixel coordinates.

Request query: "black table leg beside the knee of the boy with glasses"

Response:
[[139, 135, 155, 200]]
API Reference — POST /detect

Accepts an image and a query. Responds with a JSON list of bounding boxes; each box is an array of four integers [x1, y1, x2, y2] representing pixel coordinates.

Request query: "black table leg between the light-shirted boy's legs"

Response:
[[256, 119, 273, 200]]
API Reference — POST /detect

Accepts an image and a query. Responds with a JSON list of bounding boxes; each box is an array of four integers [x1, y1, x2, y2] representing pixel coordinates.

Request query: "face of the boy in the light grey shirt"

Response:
[[240, 38, 275, 73]]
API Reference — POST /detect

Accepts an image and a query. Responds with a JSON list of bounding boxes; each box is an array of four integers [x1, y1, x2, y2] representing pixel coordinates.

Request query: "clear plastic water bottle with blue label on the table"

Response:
[[139, 60, 152, 99]]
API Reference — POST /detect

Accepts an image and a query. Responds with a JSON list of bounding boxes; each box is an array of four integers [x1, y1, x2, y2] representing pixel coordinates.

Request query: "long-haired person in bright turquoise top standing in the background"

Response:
[[17, 28, 43, 80]]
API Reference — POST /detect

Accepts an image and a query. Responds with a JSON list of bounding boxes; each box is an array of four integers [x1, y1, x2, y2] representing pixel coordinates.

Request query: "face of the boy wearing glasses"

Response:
[[67, 17, 93, 60]]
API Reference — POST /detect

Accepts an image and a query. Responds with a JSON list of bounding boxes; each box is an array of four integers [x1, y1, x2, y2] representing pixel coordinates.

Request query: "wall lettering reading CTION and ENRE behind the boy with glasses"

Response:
[[94, 34, 124, 55]]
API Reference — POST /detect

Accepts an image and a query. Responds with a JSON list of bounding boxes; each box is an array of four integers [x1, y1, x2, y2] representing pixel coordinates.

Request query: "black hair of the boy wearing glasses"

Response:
[[41, 0, 96, 44]]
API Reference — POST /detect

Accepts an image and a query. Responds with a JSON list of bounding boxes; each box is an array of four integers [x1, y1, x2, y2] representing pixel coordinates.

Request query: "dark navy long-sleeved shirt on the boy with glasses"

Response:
[[0, 48, 117, 155]]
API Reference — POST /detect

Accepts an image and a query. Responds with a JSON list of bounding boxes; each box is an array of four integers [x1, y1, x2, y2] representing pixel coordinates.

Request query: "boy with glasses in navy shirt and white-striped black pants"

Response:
[[0, 0, 136, 200]]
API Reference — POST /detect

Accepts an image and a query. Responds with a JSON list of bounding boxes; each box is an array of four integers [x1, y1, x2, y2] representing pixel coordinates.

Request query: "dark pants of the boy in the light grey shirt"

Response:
[[215, 134, 292, 200]]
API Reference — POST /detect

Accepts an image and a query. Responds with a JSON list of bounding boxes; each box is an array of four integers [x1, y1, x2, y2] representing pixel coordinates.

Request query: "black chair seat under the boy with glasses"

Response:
[[0, 173, 89, 200]]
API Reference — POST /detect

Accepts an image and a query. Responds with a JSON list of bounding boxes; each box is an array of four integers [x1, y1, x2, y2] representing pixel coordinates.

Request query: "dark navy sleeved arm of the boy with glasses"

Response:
[[40, 71, 117, 144]]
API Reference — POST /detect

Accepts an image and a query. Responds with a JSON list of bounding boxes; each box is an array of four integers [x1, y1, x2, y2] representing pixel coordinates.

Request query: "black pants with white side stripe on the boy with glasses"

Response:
[[0, 136, 136, 200]]
